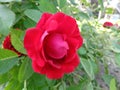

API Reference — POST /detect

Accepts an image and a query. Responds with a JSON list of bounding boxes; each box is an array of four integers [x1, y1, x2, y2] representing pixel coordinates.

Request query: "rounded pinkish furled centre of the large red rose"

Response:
[[44, 34, 69, 59]]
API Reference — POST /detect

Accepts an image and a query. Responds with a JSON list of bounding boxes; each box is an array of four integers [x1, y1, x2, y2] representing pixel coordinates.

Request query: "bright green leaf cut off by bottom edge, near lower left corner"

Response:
[[4, 80, 23, 90]]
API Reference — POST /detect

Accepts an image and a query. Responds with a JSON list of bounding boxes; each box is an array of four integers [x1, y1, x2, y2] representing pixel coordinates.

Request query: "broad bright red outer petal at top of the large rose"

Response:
[[45, 12, 76, 35]]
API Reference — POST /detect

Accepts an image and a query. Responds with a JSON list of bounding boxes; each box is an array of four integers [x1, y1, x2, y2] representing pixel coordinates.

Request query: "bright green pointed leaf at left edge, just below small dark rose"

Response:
[[0, 48, 18, 60]]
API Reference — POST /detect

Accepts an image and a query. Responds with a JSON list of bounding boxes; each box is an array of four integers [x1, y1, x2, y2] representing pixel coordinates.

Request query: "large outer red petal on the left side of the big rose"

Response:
[[24, 28, 45, 66]]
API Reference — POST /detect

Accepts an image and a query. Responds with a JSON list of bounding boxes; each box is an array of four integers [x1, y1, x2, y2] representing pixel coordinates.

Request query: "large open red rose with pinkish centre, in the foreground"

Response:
[[24, 12, 83, 79]]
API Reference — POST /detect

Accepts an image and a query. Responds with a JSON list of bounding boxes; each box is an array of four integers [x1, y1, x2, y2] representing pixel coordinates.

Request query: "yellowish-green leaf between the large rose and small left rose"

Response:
[[11, 30, 26, 54]]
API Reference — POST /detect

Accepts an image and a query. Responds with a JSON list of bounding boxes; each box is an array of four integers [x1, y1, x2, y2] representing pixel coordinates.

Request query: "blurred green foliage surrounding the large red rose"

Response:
[[0, 0, 120, 90]]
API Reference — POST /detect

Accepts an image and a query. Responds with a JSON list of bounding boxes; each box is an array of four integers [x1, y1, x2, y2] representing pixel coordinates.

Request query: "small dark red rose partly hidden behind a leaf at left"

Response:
[[3, 35, 22, 56]]
